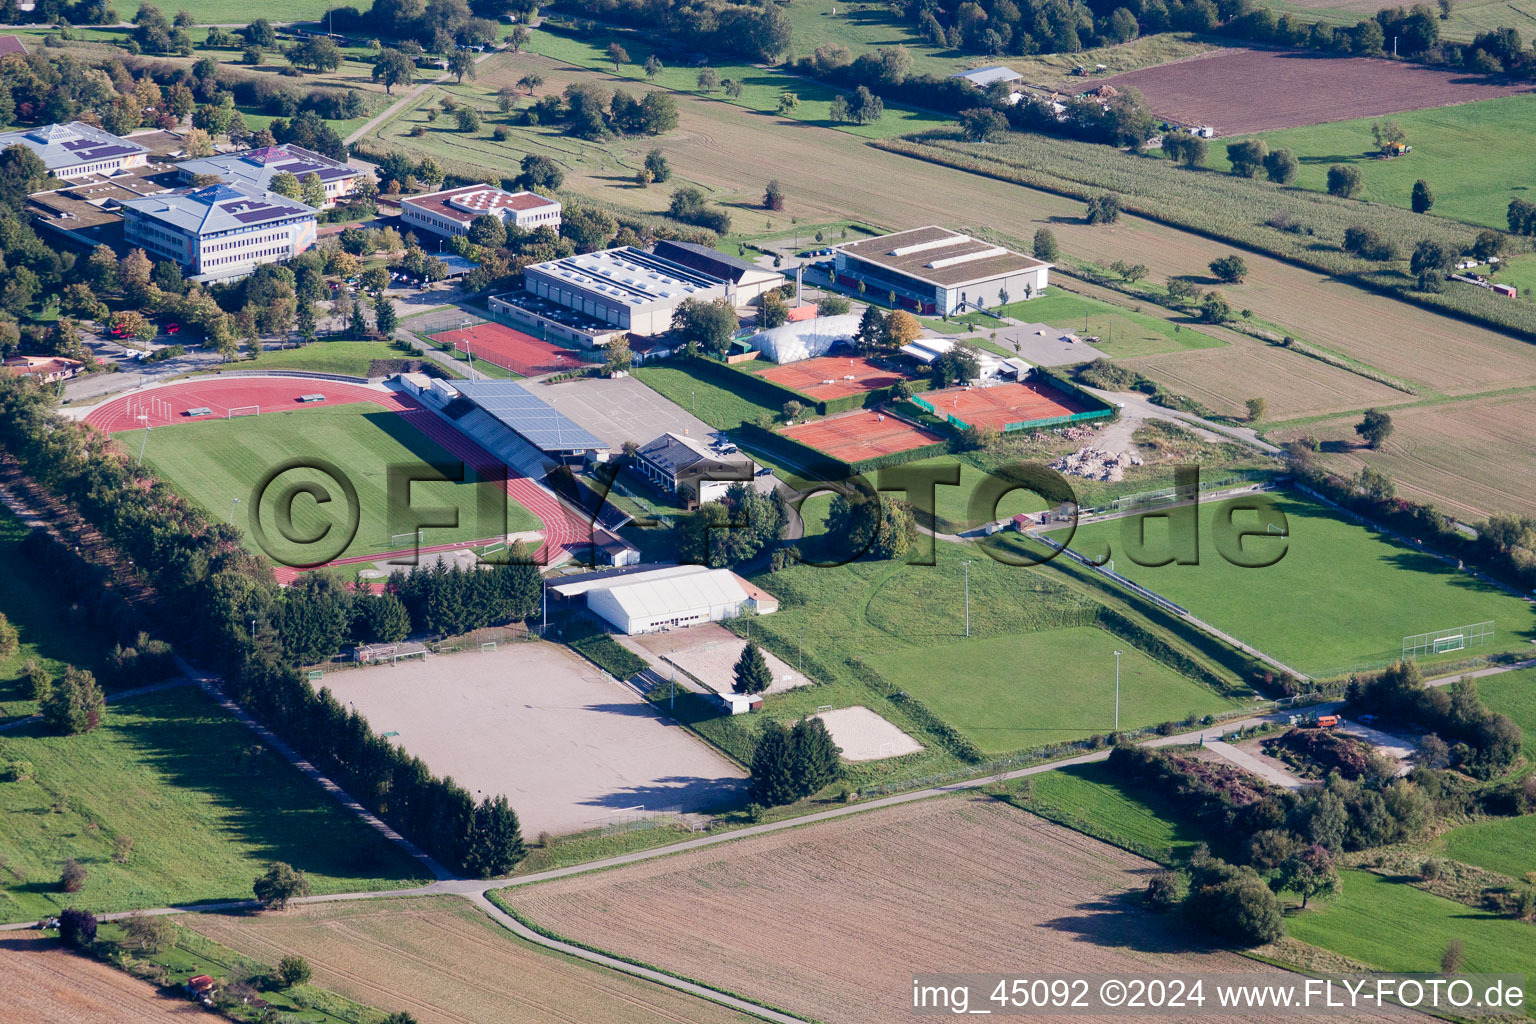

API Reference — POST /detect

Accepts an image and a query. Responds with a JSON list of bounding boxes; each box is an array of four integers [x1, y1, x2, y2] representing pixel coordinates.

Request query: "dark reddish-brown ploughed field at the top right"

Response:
[[1107, 48, 1530, 135]]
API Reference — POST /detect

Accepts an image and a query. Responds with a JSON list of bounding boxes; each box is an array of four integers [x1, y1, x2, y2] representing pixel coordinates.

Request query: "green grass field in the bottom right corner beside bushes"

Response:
[[1286, 870, 1536, 1003]]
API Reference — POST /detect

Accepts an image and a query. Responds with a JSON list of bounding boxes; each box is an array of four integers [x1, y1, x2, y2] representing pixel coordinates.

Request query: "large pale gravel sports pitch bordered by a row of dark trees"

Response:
[[324, 642, 745, 837]]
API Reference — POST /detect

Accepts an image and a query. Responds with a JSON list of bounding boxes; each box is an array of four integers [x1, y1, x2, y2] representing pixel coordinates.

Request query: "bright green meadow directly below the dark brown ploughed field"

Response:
[[1207, 94, 1536, 230]]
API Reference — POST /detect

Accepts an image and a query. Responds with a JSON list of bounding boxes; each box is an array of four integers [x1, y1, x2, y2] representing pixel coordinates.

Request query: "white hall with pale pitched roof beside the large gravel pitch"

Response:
[[550, 565, 779, 636]]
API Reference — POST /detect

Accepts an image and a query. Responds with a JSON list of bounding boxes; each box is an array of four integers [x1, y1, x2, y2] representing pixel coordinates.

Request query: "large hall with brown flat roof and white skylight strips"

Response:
[[834, 227, 1051, 316]]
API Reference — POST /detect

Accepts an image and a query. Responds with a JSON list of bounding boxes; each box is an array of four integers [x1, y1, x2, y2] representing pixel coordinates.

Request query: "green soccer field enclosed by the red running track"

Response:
[[117, 402, 544, 563]]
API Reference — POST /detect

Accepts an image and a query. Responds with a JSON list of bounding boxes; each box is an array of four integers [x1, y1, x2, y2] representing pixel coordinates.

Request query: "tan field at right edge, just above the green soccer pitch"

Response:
[[1269, 391, 1536, 520]]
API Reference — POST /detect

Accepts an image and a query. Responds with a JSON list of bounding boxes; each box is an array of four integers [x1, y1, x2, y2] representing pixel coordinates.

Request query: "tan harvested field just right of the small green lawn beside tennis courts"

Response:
[[1126, 338, 1413, 419]]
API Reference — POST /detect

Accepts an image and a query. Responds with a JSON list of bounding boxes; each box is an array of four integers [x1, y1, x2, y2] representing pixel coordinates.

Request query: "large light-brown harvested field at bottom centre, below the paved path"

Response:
[[502, 797, 1406, 1024]]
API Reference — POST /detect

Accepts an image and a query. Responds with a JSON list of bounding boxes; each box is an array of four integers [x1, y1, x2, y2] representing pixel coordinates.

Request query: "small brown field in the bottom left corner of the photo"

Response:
[[0, 933, 224, 1024]]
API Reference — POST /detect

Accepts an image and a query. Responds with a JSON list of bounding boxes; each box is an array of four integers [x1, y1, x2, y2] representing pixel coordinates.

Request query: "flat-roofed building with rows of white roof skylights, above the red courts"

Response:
[[522, 246, 730, 336]]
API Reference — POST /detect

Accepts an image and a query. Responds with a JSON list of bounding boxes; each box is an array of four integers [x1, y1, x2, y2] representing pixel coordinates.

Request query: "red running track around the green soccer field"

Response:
[[84, 378, 591, 583]]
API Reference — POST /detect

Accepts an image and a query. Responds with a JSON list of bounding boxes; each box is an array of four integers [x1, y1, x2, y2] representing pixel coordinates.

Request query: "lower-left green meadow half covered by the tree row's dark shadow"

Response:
[[0, 686, 421, 921]]
